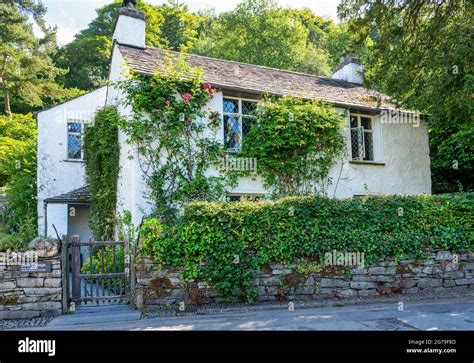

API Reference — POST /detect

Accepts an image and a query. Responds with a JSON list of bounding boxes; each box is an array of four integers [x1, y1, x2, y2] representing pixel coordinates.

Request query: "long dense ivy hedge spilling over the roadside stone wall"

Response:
[[141, 194, 474, 300]]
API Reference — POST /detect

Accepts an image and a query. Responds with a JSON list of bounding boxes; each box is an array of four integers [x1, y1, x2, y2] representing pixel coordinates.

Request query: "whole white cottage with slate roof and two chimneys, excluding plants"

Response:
[[38, 7, 431, 240]]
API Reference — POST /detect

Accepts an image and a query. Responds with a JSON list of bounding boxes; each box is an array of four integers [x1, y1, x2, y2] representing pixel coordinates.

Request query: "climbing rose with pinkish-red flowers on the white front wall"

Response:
[[119, 55, 230, 221]]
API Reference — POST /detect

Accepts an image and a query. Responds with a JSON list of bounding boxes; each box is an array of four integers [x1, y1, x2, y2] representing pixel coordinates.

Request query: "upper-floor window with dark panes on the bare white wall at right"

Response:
[[351, 114, 374, 161]]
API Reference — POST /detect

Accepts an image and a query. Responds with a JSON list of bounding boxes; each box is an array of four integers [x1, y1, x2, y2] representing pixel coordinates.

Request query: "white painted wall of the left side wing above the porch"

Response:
[[37, 87, 107, 236]]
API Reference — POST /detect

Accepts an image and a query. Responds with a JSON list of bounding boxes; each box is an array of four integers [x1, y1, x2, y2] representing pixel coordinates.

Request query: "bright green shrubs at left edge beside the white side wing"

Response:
[[0, 114, 37, 249]]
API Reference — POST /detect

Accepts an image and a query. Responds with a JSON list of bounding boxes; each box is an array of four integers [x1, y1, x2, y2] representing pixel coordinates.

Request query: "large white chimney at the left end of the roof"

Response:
[[112, 1, 146, 48]]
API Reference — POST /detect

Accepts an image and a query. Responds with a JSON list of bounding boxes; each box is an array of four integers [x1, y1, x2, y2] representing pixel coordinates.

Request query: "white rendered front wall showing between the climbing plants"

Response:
[[107, 48, 431, 228]]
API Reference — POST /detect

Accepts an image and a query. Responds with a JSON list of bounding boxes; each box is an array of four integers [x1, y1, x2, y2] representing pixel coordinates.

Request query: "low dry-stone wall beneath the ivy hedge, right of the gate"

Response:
[[134, 251, 474, 311]]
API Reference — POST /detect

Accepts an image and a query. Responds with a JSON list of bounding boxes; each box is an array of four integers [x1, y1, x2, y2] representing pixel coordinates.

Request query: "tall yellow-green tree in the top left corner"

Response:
[[0, 0, 72, 117]]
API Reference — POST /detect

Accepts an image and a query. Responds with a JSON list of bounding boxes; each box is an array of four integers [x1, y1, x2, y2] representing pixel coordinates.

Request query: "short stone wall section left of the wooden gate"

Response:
[[0, 243, 63, 319]]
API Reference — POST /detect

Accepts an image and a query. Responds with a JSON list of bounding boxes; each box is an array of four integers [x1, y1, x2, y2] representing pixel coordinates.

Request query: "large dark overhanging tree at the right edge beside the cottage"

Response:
[[339, 0, 474, 192]]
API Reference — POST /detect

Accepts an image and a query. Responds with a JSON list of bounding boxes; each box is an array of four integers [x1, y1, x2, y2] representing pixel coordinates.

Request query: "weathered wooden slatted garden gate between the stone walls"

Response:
[[69, 236, 130, 305]]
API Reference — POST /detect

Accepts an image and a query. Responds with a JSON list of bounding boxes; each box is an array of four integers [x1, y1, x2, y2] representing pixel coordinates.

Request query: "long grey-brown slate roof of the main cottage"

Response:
[[118, 44, 395, 110]]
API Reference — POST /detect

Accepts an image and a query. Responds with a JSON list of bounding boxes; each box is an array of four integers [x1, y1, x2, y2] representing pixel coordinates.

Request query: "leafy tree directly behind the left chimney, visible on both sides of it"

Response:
[[55, 0, 202, 91]]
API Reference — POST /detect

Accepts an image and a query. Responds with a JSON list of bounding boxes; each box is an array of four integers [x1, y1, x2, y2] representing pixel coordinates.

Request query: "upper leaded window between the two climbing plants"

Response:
[[224, 98, 257, 151]]
